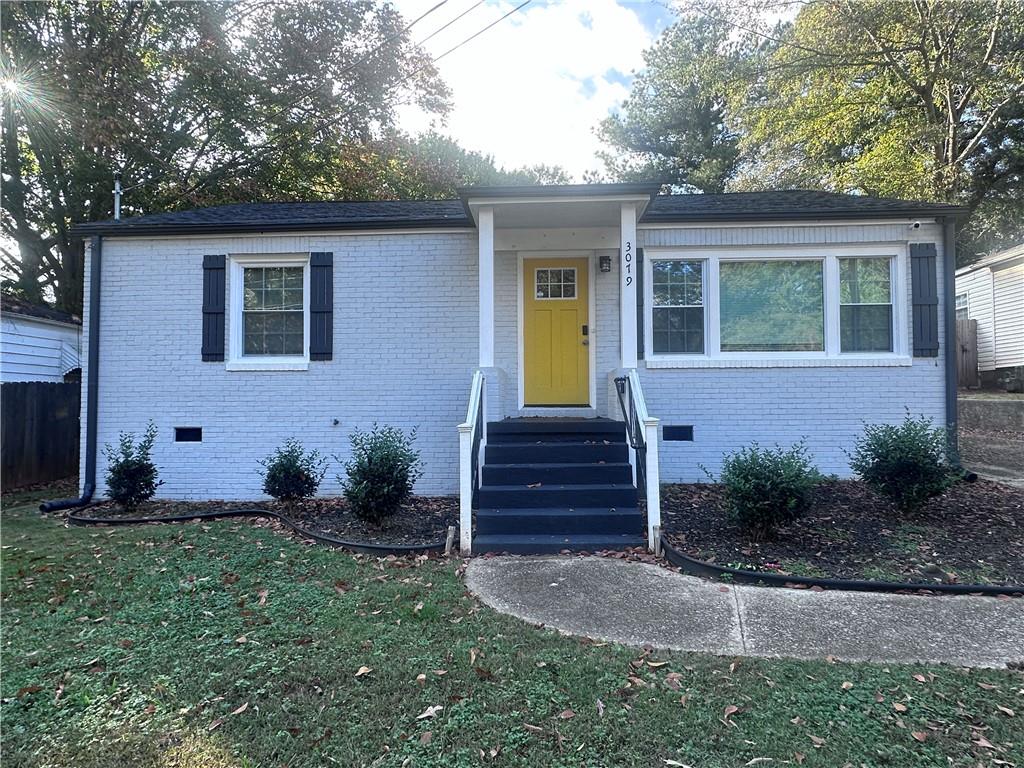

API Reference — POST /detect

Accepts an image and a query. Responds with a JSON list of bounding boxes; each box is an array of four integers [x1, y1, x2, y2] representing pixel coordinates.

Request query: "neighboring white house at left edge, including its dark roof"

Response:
[[0, 294, 82, 382]]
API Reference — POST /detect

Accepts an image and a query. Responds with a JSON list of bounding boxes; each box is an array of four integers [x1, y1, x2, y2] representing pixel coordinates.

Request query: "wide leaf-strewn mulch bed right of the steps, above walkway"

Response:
[[662, 480, 1024, 585]]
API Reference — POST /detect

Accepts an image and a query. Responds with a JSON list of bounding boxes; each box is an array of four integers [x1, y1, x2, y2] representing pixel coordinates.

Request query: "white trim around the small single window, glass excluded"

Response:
[[224, 253, 309, 371]]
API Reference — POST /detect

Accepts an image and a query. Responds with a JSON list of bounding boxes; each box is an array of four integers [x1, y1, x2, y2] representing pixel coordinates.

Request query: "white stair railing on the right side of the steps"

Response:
[[615, 368, 662, 553]]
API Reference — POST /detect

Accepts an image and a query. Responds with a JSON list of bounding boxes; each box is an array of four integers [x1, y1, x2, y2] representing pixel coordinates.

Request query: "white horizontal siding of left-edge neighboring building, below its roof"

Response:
[[0, 312, 81, 382]]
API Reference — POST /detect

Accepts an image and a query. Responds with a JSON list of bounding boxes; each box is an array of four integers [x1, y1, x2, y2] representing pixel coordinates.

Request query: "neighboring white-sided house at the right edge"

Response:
[[956, 244, 1024, 383]]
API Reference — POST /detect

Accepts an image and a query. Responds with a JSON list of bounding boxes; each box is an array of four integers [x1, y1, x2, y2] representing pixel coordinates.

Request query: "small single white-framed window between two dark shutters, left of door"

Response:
[[226, 254, 309, 371]]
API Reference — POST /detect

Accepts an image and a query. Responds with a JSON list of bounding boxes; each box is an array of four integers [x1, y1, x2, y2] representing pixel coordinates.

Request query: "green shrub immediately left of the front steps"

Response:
[[338, 424, 423, 525]]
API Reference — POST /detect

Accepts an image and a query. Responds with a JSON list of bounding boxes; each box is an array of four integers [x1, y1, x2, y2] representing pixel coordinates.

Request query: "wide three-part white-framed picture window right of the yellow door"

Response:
[[643, 243, 911, 368]]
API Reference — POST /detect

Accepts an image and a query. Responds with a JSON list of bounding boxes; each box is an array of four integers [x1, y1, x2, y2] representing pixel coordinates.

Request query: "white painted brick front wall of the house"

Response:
[[82, 224, 945, 499]]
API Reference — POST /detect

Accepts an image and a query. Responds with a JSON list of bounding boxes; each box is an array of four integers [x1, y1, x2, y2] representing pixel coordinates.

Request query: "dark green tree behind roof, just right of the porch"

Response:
[[598, 13, 748, 193]]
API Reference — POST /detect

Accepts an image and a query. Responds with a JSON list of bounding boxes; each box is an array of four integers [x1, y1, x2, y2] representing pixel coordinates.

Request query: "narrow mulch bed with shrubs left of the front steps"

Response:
[[74, 496, 459, 546]]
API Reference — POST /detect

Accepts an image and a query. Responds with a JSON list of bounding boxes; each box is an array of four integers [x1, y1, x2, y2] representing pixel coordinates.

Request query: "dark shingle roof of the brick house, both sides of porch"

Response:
[[74, 185, 964, 236]]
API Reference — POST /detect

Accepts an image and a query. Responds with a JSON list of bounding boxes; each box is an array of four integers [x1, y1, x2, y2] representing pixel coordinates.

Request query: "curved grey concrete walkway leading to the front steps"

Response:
[[466, 557, 1024, 667]]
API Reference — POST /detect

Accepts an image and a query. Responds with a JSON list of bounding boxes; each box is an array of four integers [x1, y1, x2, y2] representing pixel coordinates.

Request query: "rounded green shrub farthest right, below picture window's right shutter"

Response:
[[850, 414, 956, 514]]
